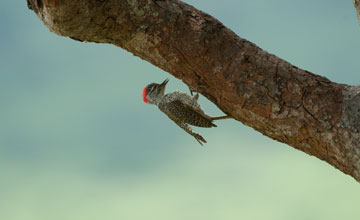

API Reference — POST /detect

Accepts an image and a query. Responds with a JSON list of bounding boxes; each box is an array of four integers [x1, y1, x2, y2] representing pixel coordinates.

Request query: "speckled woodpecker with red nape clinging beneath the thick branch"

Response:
[[142, 79, 230, 145]]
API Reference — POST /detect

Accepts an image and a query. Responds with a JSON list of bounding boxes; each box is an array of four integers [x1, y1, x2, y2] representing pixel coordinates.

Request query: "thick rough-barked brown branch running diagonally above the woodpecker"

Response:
[[27, 0, 360, 181]]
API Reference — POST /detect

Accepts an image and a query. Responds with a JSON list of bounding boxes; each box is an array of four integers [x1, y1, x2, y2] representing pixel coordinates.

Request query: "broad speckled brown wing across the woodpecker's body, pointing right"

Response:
[[159, 100, 216, 128]]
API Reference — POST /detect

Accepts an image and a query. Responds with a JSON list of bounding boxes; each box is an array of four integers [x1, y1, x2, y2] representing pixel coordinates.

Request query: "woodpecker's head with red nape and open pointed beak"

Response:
[[143, 79, 169, 104]]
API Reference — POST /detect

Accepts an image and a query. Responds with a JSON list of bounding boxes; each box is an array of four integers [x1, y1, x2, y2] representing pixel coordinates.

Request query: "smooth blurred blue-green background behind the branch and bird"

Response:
[[0, 0, 360, 220]]
